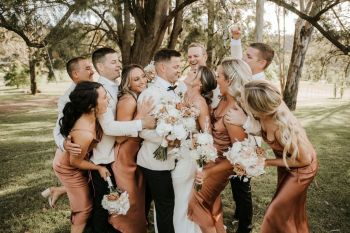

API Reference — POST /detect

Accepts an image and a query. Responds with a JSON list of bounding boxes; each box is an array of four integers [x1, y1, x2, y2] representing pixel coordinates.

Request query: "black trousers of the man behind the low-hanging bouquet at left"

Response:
[[91, 163, 119, 233]]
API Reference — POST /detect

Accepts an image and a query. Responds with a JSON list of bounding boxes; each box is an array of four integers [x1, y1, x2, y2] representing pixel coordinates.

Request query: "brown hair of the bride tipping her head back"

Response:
[[197, 66, 217, 105]]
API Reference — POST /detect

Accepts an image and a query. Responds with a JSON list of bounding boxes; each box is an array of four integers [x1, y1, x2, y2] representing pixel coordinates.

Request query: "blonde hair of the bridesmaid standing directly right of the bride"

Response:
[[221, 57, 252, 99]]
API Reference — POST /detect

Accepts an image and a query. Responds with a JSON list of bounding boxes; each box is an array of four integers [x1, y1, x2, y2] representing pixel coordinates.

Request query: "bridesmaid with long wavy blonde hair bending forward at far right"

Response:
[[242, 81, 318, 233]]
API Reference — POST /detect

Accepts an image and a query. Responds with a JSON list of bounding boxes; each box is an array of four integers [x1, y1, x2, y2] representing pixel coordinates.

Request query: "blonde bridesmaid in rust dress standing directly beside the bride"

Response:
[[188, 58, 251, 233]]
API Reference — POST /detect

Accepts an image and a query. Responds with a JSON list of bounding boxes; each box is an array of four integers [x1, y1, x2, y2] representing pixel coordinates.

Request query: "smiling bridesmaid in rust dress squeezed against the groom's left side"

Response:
[[109, 65, 147, 233]]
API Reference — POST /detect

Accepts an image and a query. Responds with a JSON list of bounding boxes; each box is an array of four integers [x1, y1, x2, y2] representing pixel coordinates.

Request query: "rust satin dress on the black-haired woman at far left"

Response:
[[53, 129, 102, 225]]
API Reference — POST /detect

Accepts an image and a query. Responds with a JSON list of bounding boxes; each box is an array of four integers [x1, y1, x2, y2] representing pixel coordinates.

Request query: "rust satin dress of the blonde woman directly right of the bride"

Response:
[[188, 106, 237, 233]]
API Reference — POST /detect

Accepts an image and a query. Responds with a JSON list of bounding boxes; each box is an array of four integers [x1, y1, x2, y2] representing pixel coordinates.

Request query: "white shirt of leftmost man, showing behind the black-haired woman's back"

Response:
[[53, 83, 76, 151]]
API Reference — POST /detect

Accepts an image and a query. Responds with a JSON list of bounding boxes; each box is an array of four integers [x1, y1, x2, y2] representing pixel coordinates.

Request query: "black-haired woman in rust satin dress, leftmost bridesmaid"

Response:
[[53, 81, 110, 233]]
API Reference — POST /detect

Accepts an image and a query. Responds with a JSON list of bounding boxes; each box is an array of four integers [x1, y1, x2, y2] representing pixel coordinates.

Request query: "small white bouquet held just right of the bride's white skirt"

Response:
[[190, 132, 217, 191]]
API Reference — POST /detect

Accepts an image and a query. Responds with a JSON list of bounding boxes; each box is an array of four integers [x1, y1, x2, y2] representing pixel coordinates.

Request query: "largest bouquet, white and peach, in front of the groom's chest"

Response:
[[153, 97, 199, 161]]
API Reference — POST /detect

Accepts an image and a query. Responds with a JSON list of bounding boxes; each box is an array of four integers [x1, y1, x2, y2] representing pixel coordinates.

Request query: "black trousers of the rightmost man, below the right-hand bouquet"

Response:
[[230, 177, 253, 233]]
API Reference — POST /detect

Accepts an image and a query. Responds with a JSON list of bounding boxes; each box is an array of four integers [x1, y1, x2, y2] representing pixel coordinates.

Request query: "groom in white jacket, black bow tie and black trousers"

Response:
[[137, 49, 181, 233]]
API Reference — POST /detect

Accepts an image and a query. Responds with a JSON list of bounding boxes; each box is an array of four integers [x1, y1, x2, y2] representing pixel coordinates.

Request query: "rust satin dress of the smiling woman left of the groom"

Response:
[[109, 97, 147, 233]]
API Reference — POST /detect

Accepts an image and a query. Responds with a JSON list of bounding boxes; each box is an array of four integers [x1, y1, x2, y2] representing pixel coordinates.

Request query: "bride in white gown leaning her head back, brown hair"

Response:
[[172, 66, 216, 233]]
